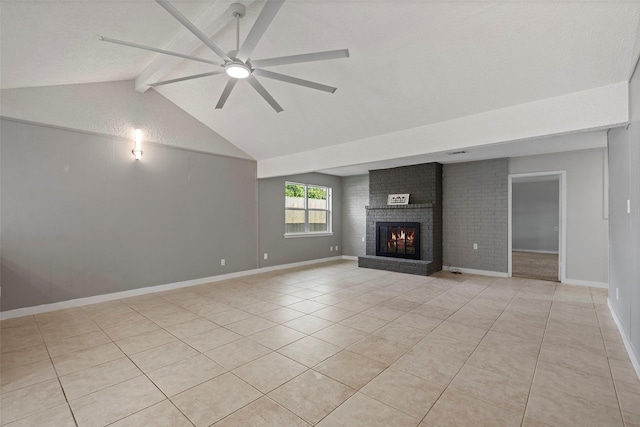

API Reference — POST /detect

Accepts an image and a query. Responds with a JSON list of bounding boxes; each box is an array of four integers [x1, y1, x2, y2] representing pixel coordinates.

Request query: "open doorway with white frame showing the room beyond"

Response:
[[509, 171, 566, 282]]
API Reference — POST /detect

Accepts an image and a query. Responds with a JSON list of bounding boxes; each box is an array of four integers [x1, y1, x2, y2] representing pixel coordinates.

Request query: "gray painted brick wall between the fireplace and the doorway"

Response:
[[443, 159, 509, 272]]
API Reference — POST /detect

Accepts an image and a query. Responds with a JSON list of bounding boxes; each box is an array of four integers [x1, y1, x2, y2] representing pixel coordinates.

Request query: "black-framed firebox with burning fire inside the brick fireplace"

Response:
[[376, 222, 420, 259]]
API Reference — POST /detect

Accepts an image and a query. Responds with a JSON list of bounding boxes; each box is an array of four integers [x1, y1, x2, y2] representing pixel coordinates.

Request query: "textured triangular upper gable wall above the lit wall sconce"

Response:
[[0, 80, 251, 159]]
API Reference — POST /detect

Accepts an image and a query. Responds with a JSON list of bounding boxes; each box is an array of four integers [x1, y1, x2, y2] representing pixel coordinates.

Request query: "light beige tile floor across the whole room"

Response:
[[0, 261, 640, 427]]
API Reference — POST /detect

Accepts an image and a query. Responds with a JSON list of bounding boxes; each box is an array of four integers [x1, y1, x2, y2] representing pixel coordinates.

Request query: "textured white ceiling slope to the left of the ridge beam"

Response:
[[0, 0, 214, 89]]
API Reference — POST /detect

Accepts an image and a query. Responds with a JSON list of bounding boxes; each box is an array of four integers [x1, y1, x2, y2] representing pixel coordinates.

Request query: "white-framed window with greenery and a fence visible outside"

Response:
[[284, 182, 331, 237]]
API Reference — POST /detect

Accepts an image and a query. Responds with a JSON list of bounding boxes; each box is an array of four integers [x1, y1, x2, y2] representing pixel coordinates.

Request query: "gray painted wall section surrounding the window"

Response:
[[258, 173, 343, 267]]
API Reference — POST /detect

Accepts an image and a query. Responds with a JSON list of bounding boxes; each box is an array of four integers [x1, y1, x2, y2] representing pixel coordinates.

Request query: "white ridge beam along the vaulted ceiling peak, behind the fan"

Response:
[[135, 0, 256, 93]]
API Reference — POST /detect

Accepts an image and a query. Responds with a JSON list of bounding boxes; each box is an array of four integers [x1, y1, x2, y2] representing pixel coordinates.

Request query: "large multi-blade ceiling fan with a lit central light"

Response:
[[98, 0, 349, 113]]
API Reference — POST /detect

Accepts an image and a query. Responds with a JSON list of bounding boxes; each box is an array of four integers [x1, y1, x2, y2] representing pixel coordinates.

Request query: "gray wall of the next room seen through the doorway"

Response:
[[511, 180, 560, 253]]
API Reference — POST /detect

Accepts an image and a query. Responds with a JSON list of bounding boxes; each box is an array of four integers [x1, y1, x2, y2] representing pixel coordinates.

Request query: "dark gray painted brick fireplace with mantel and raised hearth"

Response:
[[358, 163, 442, 275]]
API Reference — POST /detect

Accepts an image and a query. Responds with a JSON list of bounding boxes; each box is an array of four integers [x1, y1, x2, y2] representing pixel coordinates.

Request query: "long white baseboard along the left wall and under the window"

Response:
[[0, 256, 344, 320]]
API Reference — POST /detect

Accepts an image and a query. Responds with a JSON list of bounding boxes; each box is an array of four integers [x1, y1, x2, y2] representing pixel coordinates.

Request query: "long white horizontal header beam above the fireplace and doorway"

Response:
[[258, 81, 629, 179]]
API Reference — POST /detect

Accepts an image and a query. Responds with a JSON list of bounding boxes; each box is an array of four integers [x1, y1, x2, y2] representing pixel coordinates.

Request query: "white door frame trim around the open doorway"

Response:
[[507, 171, 567, 283]]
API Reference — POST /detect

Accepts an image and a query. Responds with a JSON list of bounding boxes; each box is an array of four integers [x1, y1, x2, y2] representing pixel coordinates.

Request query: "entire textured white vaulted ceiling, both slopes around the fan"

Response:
[[0, 0, 640, 171]]
